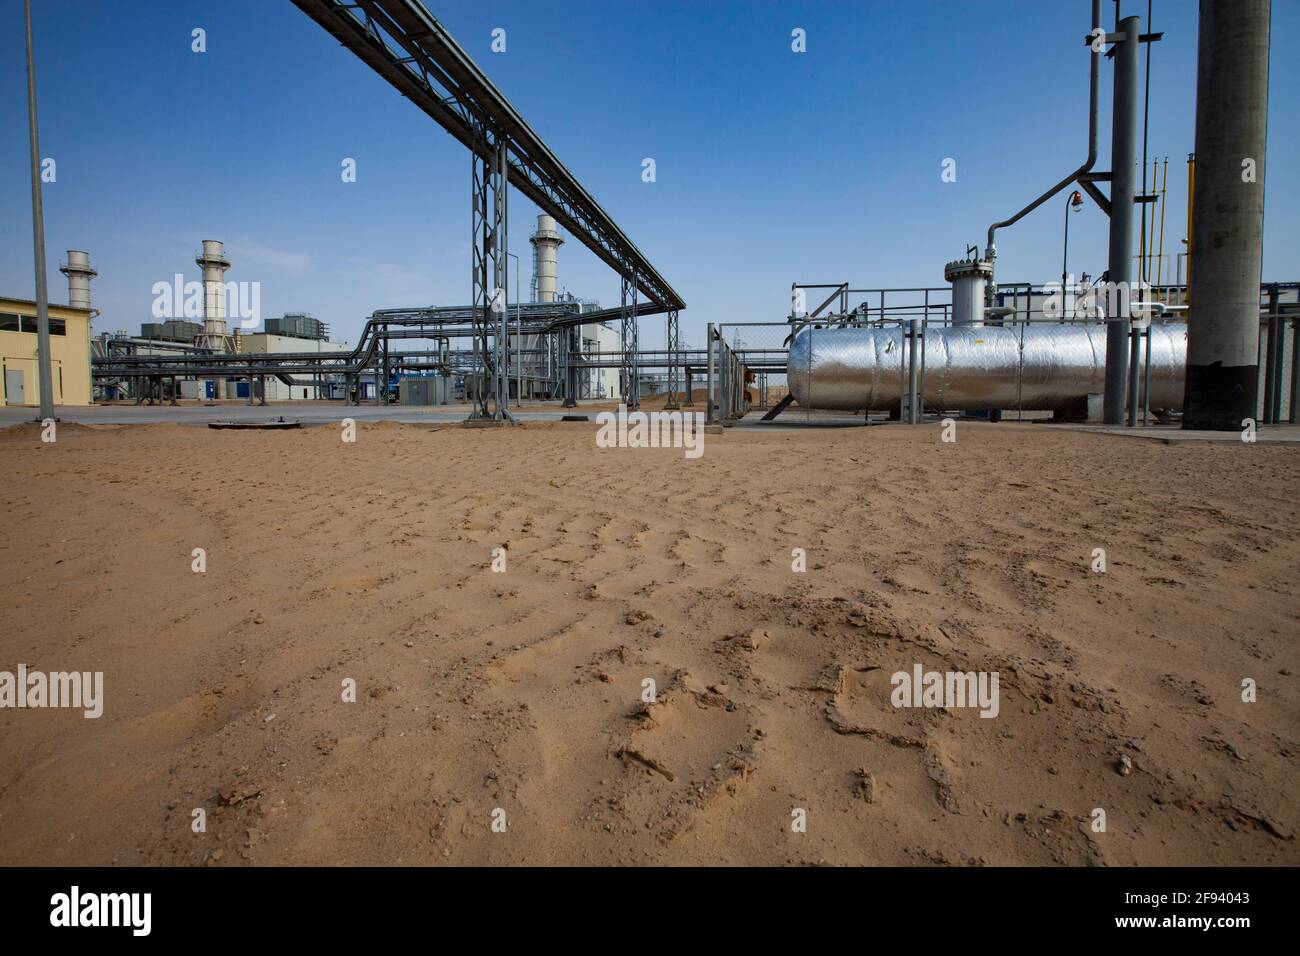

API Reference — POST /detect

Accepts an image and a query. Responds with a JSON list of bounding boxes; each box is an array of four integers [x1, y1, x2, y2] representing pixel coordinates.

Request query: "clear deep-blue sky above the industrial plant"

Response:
[[0, 0, 1300, 345]]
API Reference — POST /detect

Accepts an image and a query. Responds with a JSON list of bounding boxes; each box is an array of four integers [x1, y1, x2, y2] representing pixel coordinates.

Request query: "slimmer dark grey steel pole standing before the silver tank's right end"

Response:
[[1101, 17, 1138, 425]]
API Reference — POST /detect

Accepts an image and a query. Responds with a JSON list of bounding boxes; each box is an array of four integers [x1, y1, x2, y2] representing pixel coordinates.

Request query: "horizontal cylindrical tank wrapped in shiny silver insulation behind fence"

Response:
[[787, 323, 1187, 411]]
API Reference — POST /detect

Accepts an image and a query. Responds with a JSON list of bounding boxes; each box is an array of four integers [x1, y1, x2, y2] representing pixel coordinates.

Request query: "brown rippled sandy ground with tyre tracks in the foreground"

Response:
[[0, 423, 1300, 866]]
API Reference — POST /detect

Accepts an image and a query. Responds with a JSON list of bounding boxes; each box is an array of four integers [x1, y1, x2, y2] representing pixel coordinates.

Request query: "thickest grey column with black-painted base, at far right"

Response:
[[1183, 0, 1271, 431]]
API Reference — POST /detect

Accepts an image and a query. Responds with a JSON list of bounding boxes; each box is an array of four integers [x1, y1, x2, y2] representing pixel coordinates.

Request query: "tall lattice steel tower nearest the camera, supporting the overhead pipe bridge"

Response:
[[469, 134, 515, 421]]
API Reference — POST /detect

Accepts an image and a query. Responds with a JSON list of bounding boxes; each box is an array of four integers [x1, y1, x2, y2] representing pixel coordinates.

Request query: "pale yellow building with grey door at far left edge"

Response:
[[0, 297, 91, 406]]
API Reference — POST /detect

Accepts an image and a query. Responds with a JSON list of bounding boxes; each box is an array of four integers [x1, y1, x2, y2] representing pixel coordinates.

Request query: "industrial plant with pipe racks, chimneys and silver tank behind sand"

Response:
[[7, 0, 1300, 431]]
